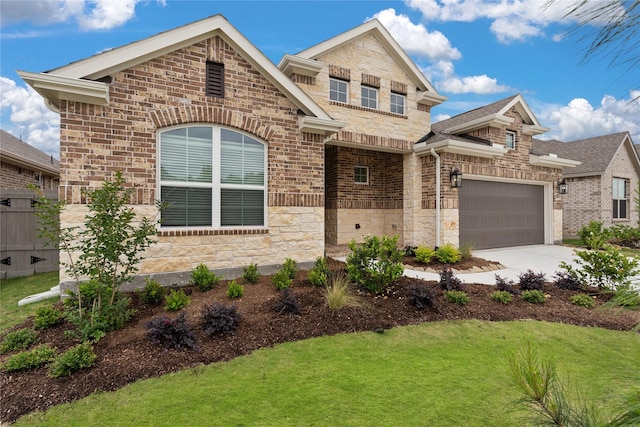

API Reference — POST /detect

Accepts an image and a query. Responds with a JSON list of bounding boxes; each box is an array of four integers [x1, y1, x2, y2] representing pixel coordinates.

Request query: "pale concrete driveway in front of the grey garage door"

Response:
[[405, 245, 575, 285]]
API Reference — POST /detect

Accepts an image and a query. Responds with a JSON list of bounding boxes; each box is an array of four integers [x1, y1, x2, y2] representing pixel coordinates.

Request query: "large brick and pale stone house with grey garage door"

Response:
[[19, 15, 574, 290]]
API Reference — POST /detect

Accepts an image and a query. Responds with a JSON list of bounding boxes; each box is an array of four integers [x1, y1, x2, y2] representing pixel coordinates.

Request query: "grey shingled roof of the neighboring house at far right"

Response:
[[532, 132, 640, 178]]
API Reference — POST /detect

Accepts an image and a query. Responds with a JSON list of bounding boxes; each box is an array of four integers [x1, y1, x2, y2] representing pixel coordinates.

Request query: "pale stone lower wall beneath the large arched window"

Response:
[[60, 205, 324, 293]]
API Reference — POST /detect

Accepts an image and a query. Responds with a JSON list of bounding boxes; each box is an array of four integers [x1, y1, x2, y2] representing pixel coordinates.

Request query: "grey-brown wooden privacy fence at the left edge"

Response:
[[0, 189, 60, 279]]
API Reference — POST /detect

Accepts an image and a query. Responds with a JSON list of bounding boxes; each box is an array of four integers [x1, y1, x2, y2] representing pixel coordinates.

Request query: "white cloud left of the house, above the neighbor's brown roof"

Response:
[[0, 77, 60, 157]]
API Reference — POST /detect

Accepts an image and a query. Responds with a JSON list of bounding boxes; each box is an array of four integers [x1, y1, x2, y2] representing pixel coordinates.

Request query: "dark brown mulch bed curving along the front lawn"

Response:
[[0, 260, 640, 422]]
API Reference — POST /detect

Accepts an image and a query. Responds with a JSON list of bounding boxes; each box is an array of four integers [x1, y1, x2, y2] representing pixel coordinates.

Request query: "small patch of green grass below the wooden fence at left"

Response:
[[0, 271, 59, 334]]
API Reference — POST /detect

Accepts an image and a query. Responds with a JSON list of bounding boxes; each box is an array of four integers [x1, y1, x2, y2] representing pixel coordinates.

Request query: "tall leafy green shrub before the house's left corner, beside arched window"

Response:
[[32, 171, 163, 338]]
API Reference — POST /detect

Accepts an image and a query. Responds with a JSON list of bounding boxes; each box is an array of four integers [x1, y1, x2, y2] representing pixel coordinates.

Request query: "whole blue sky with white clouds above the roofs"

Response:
[[0, 0, 640, 156]]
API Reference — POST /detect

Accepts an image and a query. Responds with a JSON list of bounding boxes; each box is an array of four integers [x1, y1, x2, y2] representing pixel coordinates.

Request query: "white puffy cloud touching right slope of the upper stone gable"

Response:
[[368, 9, 462, 61]]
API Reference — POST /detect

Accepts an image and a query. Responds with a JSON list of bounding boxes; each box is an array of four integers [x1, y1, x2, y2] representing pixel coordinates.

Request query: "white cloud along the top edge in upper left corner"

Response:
[[0, 0, 166, 30]]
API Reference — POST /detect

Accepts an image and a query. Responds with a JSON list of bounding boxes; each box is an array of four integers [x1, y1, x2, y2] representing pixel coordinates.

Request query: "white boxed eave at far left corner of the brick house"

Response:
[[17, 71, 109, 108]]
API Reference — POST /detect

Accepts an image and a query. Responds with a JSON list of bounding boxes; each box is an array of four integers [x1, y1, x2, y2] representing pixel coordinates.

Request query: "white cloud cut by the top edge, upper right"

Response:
[[405, 0, 598, 43]]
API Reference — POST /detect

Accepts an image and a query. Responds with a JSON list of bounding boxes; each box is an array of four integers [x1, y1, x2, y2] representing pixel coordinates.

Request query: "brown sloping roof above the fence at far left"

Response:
[[0, 129, 60, 177]]
